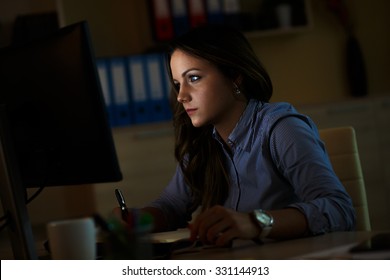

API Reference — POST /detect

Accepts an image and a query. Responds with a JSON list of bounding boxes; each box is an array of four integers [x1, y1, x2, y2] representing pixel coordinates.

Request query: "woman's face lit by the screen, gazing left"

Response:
[[170, 50, 245, 130]]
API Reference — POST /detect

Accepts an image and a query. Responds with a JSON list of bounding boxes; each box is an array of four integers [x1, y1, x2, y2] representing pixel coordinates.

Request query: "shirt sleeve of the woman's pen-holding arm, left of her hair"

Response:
[[148, 166, 192, 230]]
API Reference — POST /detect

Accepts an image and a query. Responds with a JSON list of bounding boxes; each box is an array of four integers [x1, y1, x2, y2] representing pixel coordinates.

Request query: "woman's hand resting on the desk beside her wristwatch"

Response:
[[189, 205, 260, 246]]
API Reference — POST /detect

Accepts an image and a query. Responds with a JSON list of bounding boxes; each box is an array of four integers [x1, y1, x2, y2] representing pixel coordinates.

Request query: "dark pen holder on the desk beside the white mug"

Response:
[[103, 214, 153, 260]]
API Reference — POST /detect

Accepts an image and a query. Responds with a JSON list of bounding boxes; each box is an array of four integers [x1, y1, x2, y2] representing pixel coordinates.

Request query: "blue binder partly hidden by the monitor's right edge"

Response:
[[96, 58, 116, 127]]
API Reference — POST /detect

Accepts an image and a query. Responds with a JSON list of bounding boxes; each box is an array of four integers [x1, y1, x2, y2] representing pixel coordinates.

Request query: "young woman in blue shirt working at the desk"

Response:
[[135, 26, 355, 246]]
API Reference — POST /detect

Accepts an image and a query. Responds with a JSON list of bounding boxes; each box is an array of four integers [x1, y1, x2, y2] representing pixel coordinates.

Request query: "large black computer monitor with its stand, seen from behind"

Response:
[[0, 21, 122, 258]]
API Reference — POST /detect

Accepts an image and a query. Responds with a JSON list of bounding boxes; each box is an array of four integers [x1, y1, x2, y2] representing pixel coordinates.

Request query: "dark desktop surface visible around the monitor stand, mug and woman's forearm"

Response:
[[0, 228, 390, 260]]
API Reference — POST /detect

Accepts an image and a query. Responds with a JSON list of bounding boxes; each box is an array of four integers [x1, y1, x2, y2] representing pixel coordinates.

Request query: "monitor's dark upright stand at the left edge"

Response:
[[0, 105, 38, 259]]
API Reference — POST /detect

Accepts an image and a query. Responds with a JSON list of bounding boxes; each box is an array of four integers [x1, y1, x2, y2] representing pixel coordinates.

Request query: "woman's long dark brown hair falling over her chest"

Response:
[[167, 25, 272, 210]]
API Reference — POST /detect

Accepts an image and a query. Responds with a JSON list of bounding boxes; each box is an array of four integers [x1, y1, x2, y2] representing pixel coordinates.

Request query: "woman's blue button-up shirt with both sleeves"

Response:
[[149, 100, 355, 234]]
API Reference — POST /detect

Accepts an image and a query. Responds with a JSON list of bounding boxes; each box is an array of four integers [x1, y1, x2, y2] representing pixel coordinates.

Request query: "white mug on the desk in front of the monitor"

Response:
[[47, 218, 96, 260]]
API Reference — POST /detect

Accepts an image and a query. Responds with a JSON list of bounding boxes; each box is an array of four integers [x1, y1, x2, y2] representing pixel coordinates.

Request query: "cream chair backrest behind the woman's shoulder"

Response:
[[319, 126, 371, 231]]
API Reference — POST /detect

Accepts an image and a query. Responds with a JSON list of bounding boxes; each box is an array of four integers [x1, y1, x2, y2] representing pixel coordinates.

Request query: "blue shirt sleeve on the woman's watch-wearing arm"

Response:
[[269, 116, 356, 235]]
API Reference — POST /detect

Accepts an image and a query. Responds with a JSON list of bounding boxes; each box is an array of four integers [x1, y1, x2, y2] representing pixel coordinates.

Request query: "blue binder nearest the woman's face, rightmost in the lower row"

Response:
[[145, 53, 170, 122]]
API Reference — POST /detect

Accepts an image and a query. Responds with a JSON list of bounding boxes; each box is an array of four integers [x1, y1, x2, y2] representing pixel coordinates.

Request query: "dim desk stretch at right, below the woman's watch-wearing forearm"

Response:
[[172, 231, 390, 260]]
